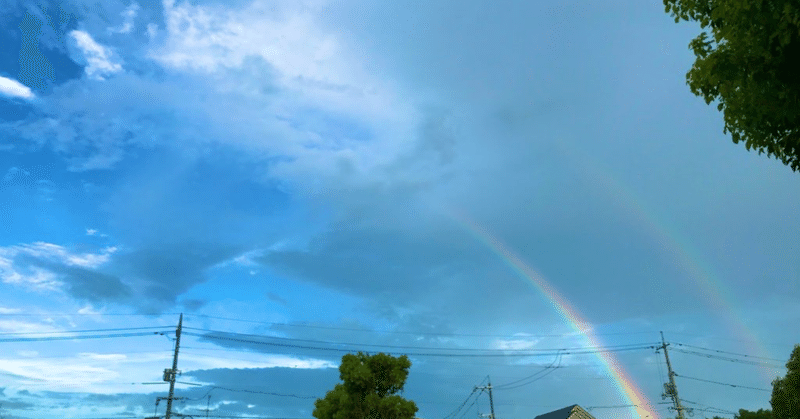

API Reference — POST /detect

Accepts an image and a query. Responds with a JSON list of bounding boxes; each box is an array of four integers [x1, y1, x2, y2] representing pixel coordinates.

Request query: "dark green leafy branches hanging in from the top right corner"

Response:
[[663, 0, 800, 171]]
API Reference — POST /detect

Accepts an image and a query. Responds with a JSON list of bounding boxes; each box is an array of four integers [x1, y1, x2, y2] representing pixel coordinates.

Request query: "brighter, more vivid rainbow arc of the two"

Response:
[[453, 214, 658, 419]]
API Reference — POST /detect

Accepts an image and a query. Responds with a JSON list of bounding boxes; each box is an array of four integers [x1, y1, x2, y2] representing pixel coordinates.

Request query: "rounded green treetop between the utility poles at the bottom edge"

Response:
[[312, 352, 417, 419]]
